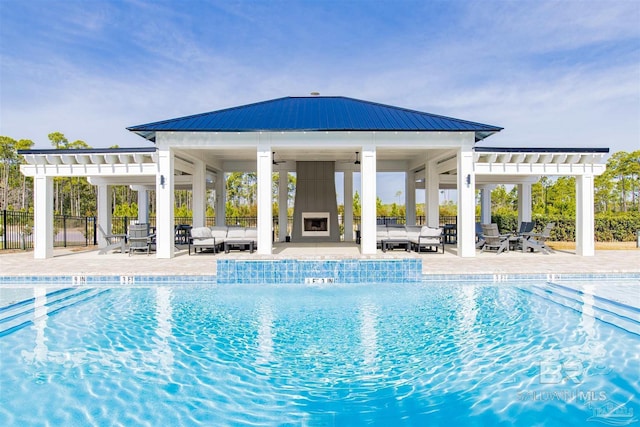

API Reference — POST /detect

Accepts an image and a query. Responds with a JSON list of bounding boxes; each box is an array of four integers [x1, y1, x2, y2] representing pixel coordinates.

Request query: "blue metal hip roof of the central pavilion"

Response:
[[127, 96, 502, 141]]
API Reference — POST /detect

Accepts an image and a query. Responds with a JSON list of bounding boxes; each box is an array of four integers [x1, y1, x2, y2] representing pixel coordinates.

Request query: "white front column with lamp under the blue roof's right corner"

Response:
[[457, 142, 476, 258]]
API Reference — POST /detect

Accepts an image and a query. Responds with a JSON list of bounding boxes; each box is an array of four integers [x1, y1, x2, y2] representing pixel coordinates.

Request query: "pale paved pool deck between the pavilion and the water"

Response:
[[0, 243, 640, 276]]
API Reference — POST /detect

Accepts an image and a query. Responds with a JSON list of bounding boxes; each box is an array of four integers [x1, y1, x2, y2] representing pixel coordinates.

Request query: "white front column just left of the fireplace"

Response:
[[257, 143, 273, 255]]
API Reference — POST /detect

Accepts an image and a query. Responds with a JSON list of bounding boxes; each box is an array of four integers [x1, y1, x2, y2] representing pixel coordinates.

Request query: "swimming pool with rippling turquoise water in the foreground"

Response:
[[0, 283, 640, 426]]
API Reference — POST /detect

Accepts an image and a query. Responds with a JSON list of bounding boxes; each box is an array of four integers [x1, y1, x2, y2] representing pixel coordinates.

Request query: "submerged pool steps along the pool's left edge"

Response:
[[0, 287, 108, 336]]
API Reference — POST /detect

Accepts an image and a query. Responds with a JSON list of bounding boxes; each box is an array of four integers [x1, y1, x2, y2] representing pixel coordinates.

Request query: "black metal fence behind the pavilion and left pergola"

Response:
[[0, 210, 457, 249]]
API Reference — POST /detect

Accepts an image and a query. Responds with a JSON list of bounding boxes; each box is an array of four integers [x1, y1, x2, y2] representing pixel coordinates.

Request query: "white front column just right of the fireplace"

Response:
[[360, 145, 377, 255]]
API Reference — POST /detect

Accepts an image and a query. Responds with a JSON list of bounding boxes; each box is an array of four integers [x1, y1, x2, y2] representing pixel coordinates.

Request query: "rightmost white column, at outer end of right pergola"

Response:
[[576, 175, 595, 256]]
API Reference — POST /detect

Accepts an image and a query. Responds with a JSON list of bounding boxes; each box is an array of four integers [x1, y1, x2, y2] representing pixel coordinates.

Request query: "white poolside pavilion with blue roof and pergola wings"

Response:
[[20, 96, 609, 258]]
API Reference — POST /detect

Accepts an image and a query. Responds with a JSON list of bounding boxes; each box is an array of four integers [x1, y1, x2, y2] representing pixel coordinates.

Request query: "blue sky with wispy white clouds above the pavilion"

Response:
[[0, 0, 640, 202]]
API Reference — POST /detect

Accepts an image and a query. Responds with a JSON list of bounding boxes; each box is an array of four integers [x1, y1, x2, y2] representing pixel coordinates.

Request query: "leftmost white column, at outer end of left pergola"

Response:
[[33, 175, 53, 259]]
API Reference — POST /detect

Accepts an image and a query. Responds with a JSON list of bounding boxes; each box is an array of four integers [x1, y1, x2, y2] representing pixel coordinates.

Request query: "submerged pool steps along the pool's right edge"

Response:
[[525, 282, 640, 335]]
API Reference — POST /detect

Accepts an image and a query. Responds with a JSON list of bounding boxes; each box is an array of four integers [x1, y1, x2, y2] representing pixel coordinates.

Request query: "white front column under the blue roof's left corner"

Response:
[[156, 145, 175, 258]]
